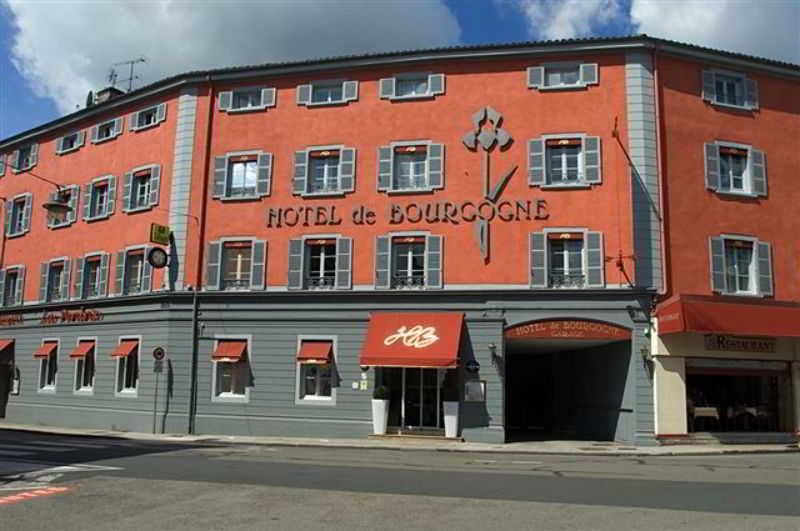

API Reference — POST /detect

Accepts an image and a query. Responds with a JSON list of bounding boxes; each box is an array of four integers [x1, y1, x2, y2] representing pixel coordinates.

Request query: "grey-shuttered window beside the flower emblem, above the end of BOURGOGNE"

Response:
[[528, 135, 602, 188]]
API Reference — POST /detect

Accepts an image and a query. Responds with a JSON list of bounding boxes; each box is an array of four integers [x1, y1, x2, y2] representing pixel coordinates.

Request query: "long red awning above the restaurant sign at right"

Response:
[[656, 295, 800, 337]]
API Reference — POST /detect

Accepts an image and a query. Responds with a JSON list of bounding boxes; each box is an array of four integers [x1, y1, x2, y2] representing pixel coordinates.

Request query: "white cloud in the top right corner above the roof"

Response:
[[631, 0, 800, 64]]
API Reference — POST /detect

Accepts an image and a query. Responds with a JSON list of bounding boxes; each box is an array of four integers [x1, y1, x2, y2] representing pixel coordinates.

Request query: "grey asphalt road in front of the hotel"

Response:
[[0, 430, 800, 531]]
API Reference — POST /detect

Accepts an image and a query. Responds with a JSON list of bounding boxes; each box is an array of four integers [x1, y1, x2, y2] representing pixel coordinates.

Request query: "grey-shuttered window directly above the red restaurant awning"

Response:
[[710, 236, 773, 296]]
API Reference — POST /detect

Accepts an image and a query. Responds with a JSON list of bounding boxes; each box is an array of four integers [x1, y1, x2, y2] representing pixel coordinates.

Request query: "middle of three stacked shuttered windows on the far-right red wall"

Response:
[[704, 142, 767, 197]]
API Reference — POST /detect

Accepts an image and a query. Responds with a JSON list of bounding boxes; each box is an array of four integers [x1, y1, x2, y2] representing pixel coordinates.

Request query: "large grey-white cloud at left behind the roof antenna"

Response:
[[0, 0, 460, 113]]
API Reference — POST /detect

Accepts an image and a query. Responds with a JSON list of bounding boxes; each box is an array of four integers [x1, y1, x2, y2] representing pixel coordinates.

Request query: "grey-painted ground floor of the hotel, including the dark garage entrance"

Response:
[[0, 290, 655, 445]]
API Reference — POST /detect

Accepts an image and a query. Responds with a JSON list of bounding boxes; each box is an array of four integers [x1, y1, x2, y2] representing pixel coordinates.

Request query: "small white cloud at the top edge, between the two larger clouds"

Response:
[[495, 0, 625, 40]]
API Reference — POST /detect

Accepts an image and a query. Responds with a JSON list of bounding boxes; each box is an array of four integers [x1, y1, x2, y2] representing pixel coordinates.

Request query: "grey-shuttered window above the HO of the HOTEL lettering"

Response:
[[213, 151, 272, 200]]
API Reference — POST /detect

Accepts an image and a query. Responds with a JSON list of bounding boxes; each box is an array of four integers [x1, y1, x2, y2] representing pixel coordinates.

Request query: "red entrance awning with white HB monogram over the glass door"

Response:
[[361, 313, 464, 368]]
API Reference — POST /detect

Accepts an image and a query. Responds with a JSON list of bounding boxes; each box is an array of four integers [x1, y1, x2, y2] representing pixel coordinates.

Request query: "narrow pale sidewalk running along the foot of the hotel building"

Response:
[[0, 423, 800, 456]]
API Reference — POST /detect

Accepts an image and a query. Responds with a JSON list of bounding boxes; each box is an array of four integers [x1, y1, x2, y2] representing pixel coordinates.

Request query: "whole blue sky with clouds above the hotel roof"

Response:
[[0, 0, 800, 139]]
